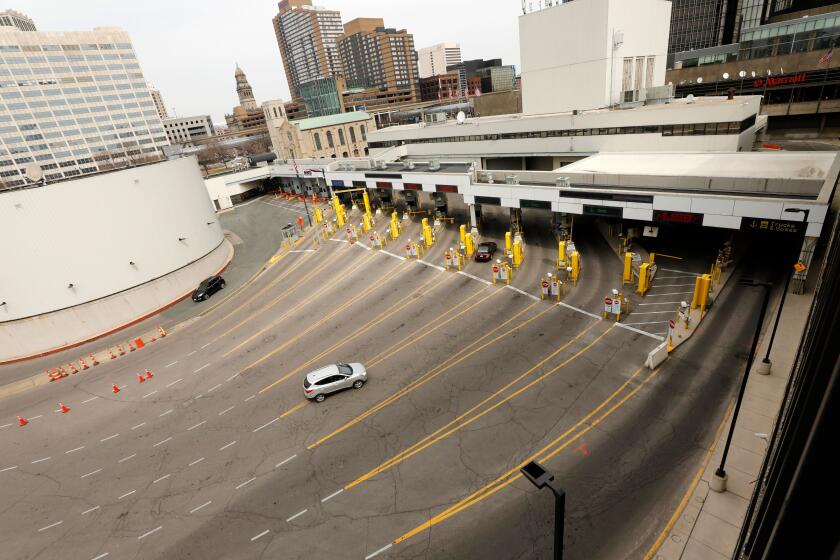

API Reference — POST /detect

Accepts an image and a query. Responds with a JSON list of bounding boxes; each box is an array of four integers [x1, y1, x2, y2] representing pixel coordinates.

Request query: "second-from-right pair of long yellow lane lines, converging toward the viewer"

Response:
[[344, 320, 613, 490]]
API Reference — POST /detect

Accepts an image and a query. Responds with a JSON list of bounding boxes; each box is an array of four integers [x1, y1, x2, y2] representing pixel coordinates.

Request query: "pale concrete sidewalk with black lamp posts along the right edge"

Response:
[[645, 284, 813, 560]]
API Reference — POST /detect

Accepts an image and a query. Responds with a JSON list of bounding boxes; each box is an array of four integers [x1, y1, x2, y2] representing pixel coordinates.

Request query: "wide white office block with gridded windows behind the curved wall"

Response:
[[0, 22, 169, 186]]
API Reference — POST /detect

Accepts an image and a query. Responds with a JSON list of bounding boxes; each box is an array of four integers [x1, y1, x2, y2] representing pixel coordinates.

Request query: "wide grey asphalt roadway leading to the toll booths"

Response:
[[0, 203, 758, 559]]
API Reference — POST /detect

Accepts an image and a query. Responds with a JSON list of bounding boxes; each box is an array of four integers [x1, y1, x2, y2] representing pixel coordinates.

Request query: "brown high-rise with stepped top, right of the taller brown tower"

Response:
[[337, 18, 417, 108]]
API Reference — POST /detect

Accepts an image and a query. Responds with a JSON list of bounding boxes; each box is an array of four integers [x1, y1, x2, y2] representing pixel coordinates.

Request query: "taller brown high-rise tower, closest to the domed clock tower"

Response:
[[272, 0, 344, 98]]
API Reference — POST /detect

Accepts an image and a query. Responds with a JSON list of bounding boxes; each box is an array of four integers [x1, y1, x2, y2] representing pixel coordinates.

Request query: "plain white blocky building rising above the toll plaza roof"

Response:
[[519, 0, 671, 114]]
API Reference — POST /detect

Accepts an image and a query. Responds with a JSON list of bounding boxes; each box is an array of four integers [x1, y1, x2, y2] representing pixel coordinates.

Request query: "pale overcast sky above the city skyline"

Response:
[[24, 0, 521, 124]]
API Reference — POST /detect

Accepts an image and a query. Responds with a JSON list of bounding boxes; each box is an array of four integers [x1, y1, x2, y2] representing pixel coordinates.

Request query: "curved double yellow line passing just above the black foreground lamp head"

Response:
[[393, 365, 662, 544]]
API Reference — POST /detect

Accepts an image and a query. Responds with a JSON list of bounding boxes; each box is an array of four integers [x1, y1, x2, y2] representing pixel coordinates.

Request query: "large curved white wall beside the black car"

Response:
[[0, 158, 227, 360]]
